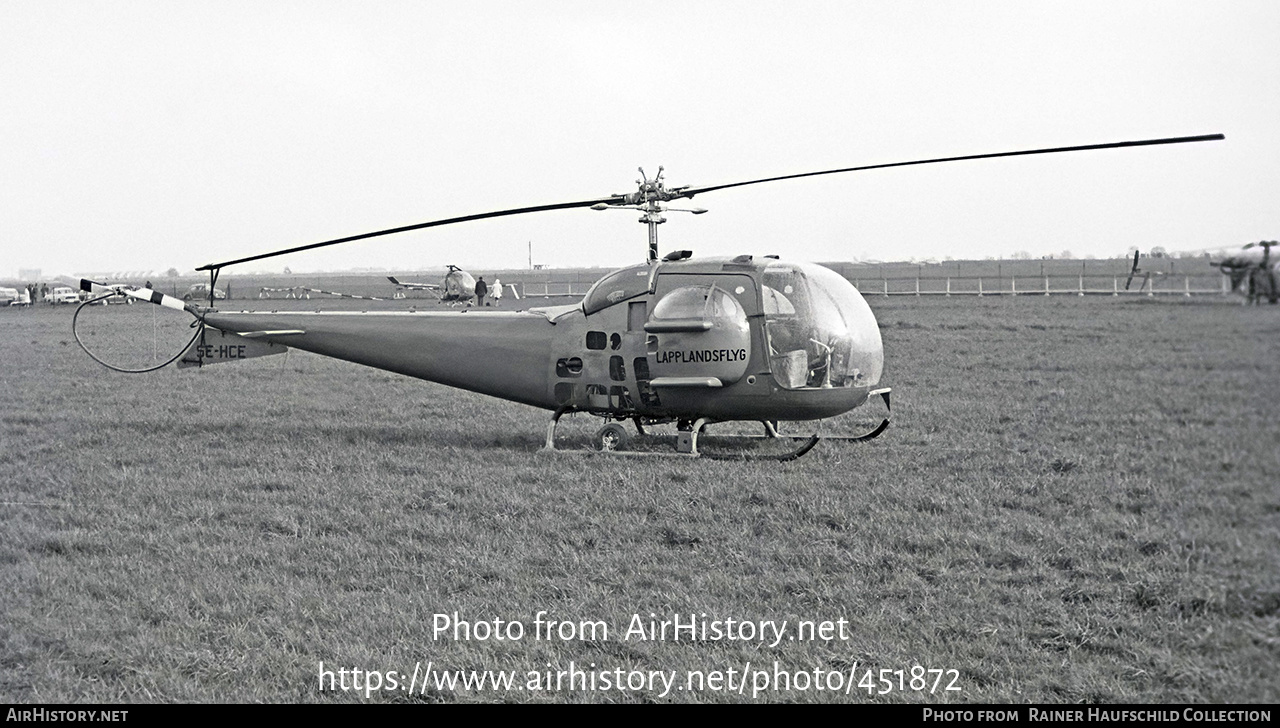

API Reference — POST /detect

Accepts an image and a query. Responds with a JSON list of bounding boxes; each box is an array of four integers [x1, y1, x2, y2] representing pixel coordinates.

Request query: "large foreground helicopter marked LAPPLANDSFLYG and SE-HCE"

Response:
[[73, 134, 1225, 461]]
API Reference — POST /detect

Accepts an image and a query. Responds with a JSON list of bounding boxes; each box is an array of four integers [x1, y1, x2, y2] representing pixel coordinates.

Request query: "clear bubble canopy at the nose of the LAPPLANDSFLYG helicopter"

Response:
[[762, 262, 884, 389]]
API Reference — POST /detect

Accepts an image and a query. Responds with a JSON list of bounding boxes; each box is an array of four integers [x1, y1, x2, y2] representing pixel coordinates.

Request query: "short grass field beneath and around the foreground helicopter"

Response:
[[0, 297, 1280, 702]]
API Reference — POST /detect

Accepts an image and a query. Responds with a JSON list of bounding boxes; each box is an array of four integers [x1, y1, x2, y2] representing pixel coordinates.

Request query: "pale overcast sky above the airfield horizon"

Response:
[[0, 0, 1280, 276]]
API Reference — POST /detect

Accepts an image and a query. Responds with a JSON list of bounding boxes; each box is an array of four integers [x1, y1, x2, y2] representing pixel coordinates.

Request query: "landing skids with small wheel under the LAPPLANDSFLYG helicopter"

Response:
[[543, 388, 892, 463]]
